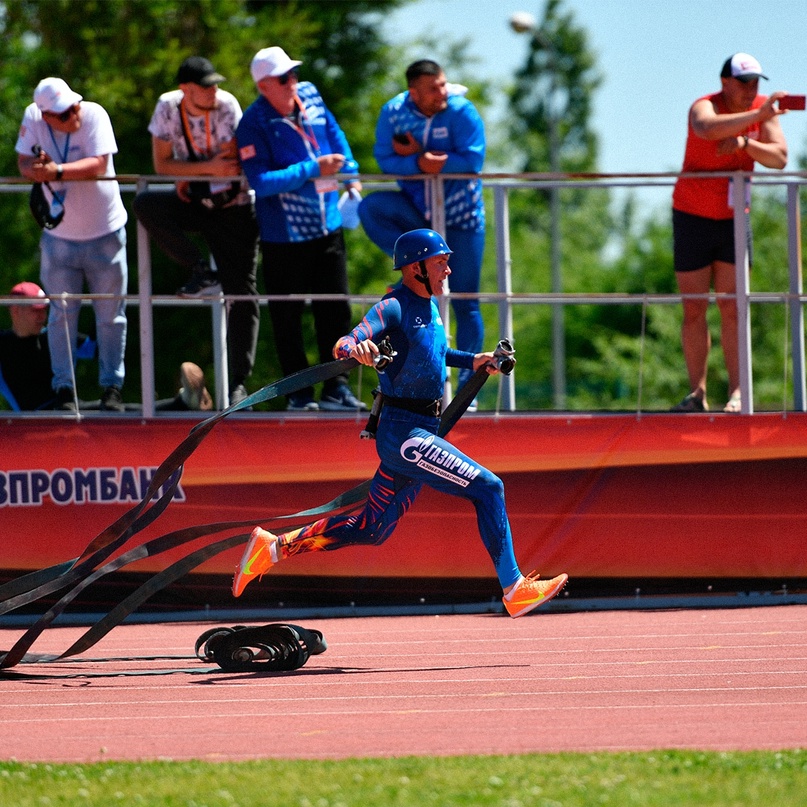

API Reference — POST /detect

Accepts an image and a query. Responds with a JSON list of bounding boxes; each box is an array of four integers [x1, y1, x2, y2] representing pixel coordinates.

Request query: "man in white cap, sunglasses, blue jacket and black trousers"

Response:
[[236, 47, 367, 410]]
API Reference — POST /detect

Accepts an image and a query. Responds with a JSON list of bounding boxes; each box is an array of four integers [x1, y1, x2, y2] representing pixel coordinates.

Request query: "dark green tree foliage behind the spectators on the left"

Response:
[[0, 0, 414, 404]]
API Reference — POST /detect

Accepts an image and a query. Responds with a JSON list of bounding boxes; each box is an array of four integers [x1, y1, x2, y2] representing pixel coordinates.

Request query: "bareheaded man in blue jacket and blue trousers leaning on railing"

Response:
[[359, 59, 485, 394]]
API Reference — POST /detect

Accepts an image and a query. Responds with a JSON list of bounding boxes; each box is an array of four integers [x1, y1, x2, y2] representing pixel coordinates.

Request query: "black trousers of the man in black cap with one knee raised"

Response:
[[133, 190, 260, 388]]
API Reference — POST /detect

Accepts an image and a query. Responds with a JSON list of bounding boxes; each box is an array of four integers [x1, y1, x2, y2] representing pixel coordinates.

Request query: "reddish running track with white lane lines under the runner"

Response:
[[0, 605, 807, 762]]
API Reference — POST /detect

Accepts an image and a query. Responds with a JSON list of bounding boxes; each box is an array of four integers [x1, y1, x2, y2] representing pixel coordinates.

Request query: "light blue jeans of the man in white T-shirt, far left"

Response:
[[39, 227, 128, 390]]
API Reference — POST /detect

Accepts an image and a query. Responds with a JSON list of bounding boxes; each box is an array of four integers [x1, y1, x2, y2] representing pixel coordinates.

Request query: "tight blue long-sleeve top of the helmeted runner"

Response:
[[336, 286, 474, 400]]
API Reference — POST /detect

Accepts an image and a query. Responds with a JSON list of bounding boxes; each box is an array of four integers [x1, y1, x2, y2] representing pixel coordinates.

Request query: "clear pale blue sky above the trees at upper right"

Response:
[[385, 0, 807, 200]]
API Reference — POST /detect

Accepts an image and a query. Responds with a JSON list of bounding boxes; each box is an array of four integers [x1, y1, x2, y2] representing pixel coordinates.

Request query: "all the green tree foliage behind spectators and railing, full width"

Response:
[[0, 0, 807, 410]]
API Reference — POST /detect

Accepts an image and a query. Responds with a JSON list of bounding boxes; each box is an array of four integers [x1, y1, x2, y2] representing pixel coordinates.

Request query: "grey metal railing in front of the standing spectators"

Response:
[[0, 172, 807, 417]]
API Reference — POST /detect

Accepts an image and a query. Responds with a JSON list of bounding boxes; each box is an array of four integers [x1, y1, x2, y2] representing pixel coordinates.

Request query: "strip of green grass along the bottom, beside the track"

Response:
[[0, 750, 807, 807]]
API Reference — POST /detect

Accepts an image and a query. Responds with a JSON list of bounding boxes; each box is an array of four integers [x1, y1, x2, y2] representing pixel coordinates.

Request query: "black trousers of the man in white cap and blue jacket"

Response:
[[261, 229, 351, 395]]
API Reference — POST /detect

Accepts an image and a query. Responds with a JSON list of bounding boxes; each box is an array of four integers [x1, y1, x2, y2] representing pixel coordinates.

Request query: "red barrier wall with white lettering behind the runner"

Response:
[[0, 414, 807, 578]]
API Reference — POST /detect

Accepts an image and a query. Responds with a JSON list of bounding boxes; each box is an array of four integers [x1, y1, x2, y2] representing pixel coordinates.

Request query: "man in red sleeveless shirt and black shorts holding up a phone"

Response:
[[672, 53, 787, 412]]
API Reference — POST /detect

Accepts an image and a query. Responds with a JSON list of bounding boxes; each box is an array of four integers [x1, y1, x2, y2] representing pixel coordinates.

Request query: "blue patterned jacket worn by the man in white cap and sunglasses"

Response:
[[235, 81, 359, 243]]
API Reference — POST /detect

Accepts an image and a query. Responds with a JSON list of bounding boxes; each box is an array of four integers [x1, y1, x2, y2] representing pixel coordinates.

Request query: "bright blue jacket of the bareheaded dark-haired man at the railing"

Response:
[[373, 91, 485, 230]]
